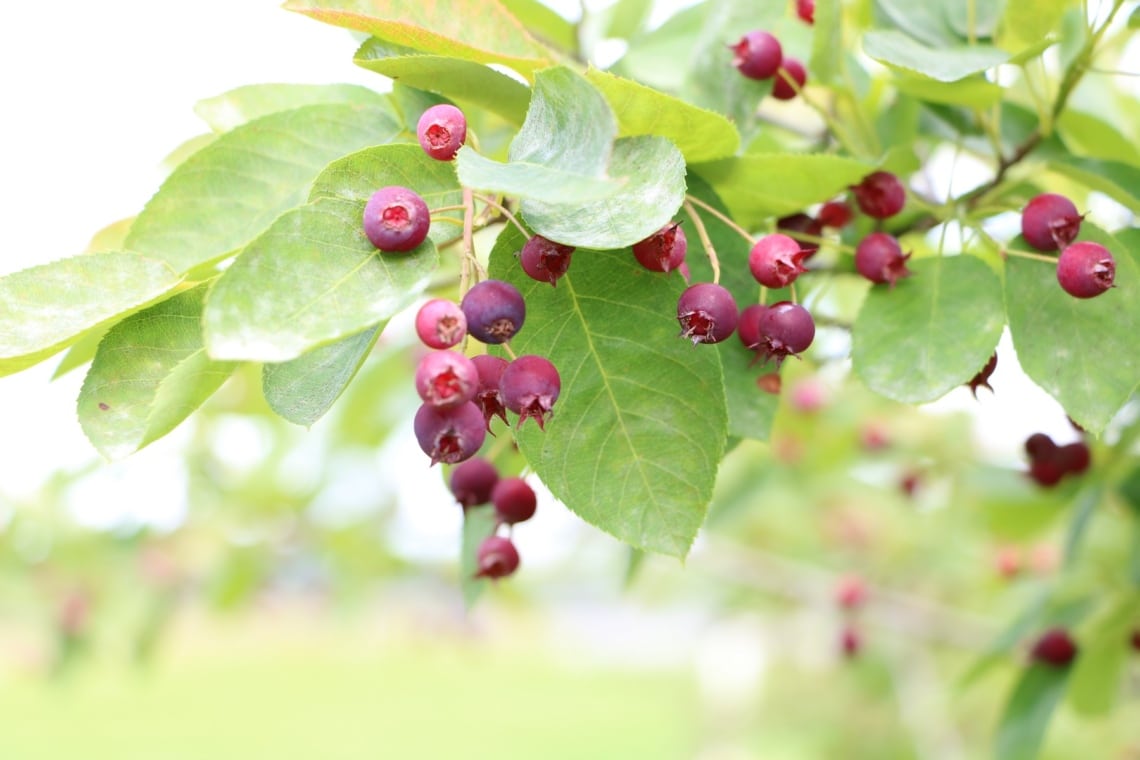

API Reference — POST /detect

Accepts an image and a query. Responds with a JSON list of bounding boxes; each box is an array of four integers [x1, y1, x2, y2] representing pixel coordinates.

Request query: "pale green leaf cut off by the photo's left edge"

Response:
[[0, 251, 181, 375]]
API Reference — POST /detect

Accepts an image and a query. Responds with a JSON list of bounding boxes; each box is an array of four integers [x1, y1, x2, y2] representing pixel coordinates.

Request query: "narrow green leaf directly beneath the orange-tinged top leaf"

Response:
[[353, 38, 530, 124]]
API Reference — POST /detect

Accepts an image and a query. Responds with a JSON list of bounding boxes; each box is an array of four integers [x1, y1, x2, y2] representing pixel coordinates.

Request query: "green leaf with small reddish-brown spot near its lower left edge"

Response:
[[78, 284, 236, 459]]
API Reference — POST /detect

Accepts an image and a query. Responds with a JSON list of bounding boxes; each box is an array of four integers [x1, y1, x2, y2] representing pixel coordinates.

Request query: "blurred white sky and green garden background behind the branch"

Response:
[[0, 0, 1140, 760]]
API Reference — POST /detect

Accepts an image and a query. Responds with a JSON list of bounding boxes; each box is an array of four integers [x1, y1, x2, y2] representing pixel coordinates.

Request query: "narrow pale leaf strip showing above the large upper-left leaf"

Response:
[[194, 84, 386, 132]]
